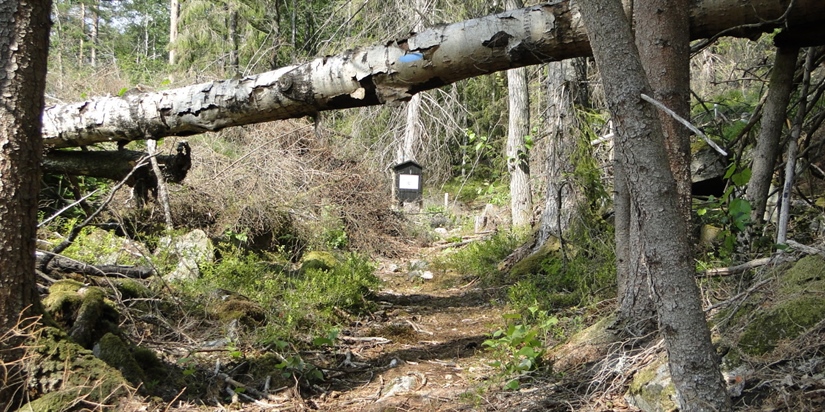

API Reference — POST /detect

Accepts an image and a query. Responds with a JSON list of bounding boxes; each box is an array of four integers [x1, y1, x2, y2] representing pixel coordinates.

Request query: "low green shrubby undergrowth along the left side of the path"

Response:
[[178, 249, 380, 343]]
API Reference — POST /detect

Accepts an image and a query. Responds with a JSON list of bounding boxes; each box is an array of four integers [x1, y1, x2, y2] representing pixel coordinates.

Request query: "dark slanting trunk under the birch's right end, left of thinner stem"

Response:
[[745, 47, 799, 223]]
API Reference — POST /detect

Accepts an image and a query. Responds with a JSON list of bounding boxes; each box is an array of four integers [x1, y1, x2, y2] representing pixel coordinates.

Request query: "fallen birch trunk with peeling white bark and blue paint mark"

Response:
[[42, 0, 825, 148]]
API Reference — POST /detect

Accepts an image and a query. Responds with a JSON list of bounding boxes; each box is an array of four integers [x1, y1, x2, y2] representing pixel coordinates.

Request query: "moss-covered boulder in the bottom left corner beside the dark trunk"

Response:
[[20, 327, 132, 412]]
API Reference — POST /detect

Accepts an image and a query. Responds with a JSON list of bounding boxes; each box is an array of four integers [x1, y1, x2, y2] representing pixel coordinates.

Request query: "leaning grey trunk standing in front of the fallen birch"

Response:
[[579, 0, 731, 412]]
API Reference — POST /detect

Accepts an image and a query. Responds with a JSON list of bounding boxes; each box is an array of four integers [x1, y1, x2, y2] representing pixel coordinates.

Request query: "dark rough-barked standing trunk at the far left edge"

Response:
[[0, 0, 51, 405]]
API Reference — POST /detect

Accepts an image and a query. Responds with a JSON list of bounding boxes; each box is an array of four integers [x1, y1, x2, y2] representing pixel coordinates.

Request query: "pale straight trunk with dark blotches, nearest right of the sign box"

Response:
[[505, 0, 533, 229]]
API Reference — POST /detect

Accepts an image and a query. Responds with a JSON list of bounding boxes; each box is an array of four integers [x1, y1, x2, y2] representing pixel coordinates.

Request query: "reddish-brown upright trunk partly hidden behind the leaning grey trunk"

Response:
[[614, 0, 691, 336]]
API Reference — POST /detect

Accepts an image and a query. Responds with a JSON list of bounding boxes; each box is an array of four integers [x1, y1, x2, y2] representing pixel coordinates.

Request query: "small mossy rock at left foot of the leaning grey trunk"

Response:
[[625, 356, 679, 412]]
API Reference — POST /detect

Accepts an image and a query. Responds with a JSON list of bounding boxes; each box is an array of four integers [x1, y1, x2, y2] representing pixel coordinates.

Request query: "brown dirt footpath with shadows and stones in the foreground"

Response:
[[316, 251, 505, 411]]
